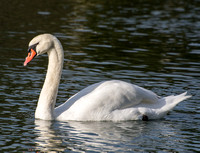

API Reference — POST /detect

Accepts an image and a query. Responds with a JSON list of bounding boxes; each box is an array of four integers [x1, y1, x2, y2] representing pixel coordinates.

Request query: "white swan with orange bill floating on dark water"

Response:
[[24, 34, 191, 121]]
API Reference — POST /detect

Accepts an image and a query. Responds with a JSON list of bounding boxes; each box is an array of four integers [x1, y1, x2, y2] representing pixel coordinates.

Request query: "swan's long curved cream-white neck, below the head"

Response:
[[35, 38, 64, 120]]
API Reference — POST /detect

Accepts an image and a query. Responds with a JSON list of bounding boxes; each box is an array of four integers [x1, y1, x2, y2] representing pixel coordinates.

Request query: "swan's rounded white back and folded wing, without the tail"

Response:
[[55, 80, 158, 120]]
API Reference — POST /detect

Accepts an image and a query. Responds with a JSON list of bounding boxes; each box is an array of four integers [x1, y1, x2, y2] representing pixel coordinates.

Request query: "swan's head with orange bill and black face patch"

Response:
[[24, 34, 56, 66]]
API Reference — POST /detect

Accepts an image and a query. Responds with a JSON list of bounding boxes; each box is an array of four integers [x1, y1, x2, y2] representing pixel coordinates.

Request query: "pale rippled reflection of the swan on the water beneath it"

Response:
[[35, 120, 176, 152]]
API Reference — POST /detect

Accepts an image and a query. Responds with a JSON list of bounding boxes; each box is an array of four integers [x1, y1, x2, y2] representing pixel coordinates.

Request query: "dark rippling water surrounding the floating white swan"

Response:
[[0, 0, 200, 152]]
